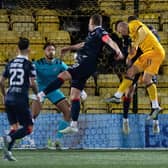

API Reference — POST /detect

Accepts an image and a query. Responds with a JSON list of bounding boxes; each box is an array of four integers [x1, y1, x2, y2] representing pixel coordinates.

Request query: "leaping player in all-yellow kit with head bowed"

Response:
[[106, 17, 165, 119]]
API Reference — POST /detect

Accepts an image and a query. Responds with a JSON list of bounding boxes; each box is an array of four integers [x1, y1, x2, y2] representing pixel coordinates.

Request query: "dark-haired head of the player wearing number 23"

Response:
[[18, 37, 30, 55]]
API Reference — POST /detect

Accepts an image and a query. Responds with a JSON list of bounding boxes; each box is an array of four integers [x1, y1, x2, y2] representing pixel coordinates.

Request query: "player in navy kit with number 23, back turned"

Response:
[[0, 38, 37, 161]]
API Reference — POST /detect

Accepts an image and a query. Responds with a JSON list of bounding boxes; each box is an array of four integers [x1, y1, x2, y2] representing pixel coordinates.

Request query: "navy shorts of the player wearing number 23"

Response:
[[5, 103, 33, 126]]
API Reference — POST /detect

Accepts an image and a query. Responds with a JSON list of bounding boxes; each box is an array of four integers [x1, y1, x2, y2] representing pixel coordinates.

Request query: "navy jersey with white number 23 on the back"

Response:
[[3, 55, 36, 101]]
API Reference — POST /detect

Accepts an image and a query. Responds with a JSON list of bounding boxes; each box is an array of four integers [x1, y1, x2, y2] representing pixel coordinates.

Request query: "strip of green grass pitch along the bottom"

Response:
[[0, 150, 168, 168]]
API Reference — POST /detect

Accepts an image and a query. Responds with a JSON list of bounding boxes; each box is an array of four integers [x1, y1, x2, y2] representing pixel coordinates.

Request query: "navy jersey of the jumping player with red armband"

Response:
[[77, 26, 108, 63]]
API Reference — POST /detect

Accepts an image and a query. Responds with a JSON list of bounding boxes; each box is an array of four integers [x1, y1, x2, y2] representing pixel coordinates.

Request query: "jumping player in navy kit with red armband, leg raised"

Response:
[[38, 14, 123, 133]]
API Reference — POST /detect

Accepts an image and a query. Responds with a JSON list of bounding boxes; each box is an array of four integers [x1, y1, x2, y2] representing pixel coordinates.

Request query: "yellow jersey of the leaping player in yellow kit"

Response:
[[129, 20, 164, 53]]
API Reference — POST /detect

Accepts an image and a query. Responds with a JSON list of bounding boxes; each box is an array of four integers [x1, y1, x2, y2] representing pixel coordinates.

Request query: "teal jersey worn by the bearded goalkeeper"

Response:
[[34, 58, 68, 90]]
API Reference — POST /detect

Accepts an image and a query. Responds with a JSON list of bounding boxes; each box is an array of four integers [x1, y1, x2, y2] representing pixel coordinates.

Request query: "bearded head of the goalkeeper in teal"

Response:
[[43, 42, 56, 60]]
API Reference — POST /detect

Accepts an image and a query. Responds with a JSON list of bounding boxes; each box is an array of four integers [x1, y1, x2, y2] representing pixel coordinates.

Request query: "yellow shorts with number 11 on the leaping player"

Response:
[[134, 50, 165, 75]]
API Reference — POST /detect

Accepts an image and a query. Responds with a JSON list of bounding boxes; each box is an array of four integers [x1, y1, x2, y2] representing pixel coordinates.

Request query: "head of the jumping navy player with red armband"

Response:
[[89, 14, 102, 31]]
